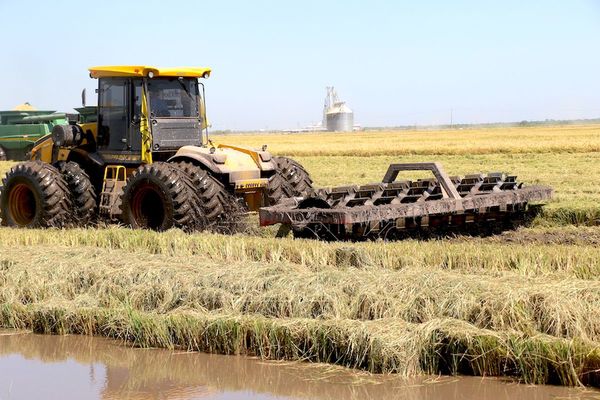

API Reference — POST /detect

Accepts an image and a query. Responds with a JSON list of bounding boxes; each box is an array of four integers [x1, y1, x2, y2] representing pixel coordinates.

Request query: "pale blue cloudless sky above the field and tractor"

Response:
[[0, 0, 600, 130]]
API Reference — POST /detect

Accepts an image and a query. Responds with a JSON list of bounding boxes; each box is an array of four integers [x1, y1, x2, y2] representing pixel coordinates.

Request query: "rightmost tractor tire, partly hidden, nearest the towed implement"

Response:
[[267, 157, 313, 205]]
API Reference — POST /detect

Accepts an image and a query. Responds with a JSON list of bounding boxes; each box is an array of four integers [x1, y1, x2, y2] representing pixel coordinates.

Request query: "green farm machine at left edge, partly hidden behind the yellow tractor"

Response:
[[0, 103, 68, 161]]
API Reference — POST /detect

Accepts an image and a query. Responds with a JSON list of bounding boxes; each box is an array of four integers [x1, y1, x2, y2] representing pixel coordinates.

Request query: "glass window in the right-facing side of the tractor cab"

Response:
[[148, 78, 199, 118]]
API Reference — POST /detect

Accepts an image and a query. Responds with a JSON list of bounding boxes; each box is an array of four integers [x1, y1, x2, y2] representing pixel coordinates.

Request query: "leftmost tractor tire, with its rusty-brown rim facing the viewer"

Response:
[[0, 161, 71, 228]]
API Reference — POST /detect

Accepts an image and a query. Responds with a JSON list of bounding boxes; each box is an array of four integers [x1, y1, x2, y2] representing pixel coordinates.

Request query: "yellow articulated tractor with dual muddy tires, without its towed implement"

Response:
[[0, 66, 312, 230]]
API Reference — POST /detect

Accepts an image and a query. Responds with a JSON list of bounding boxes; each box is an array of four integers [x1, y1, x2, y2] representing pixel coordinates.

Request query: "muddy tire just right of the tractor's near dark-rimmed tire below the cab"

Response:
[[175, 162, 243, 231]]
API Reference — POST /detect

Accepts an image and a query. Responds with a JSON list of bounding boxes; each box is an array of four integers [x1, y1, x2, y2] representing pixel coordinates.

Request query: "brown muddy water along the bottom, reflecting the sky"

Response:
[[0, 331, 600, 400]]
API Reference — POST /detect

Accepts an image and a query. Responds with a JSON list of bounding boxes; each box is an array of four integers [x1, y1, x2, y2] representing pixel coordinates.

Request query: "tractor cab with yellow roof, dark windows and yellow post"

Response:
[[90, 66, 210, 162]]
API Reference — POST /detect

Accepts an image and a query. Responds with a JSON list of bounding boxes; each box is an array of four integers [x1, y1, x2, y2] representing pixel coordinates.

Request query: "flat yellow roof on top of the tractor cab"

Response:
[[89, 65, 211, 78]]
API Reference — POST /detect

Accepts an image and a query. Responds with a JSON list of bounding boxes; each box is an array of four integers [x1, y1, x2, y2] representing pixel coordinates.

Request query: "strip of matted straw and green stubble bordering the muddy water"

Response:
[[0, 304, 600, 386]]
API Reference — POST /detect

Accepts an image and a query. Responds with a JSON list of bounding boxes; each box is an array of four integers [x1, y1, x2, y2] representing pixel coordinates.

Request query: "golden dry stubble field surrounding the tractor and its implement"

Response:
[[0, 125, 600, 386]]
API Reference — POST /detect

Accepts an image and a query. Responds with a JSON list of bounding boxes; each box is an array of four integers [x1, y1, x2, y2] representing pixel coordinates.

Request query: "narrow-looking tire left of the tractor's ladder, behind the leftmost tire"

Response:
[[55, 161, 97, 226]]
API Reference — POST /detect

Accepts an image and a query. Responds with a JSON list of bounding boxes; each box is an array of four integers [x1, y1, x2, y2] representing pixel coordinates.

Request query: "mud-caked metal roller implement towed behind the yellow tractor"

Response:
[[259, 162, 552, 240]]
